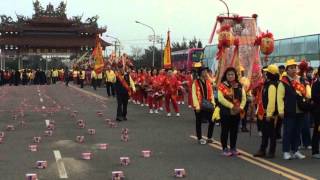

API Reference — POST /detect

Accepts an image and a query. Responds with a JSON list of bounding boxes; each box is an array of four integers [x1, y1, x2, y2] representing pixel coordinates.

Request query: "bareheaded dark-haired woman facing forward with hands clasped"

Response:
[[218, 67, 247, 156]]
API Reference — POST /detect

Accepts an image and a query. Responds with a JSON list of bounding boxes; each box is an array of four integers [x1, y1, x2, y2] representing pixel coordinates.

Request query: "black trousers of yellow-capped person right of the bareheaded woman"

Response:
[[260, 118, 276, 154]]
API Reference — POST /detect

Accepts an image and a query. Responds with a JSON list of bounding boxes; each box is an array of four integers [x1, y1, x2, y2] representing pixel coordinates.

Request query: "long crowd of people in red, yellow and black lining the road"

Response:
[[0, 59, 320, 160]]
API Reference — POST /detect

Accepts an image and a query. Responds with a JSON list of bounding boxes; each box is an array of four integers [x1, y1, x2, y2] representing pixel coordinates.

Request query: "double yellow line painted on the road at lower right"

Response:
[[190, 135, 316, 180]]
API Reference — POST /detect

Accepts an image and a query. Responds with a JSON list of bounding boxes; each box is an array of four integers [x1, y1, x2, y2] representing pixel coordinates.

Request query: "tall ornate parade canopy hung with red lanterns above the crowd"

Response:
[[209, 13, 274, 88]]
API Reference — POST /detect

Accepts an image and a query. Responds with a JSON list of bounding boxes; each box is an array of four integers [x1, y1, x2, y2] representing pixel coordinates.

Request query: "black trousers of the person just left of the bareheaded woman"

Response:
[[195, 111, 214, 140]]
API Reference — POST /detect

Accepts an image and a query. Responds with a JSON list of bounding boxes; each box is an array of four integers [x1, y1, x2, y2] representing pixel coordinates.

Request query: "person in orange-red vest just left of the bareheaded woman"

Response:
[[192, 67, 215, 144]]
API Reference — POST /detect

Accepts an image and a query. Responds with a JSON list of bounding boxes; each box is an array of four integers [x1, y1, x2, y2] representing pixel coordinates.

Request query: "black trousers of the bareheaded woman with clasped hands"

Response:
[[220, 115, 240, 150]]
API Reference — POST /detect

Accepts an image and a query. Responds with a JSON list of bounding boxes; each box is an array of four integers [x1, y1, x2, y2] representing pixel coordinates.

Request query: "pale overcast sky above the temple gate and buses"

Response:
[[0, 0, 320, 54]]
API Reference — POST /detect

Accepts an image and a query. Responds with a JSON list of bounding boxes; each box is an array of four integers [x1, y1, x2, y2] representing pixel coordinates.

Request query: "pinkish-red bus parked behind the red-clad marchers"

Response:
[[171, 48, 203, 71]]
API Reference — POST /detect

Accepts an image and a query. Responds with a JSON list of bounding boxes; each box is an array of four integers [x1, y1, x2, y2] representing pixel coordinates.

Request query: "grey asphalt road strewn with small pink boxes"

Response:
[[0, 84, 320, 180]]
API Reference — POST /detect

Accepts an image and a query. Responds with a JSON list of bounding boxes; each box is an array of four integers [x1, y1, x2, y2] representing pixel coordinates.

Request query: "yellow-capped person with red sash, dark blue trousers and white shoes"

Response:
[[277, 59, 311, 160]]
